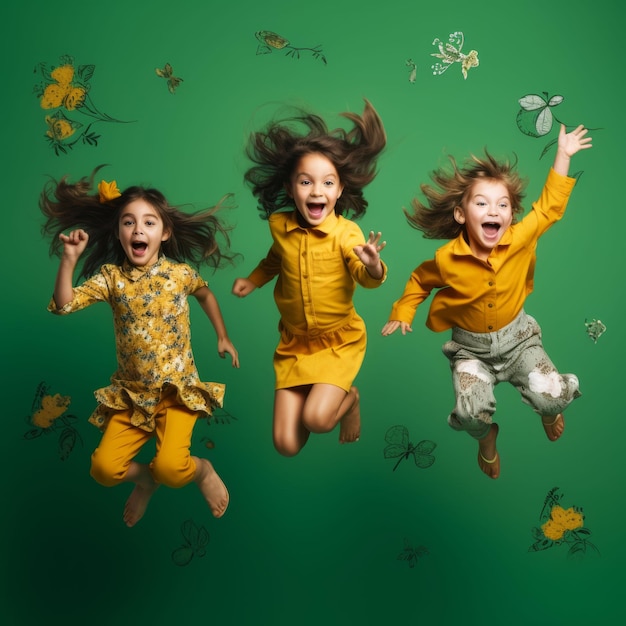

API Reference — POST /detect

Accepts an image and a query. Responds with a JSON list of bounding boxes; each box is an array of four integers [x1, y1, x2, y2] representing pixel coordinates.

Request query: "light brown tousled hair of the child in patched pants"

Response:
[[403, 150, 526, 239]]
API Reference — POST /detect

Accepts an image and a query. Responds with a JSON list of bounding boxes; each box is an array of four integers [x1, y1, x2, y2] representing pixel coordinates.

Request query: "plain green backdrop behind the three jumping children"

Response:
[[0, 0, 626, 626]]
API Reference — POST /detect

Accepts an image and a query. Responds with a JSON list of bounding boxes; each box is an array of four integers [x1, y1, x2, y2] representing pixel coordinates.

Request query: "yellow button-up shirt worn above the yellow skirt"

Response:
[[248, 211, 387, 335]]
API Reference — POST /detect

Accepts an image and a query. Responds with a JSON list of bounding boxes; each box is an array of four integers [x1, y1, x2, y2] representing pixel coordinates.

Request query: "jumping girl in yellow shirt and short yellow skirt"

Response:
[[233, 101, 386, 456]]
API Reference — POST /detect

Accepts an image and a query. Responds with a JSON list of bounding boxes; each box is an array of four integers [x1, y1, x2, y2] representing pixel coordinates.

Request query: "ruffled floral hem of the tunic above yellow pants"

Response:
[[89, 382, 226, 432]]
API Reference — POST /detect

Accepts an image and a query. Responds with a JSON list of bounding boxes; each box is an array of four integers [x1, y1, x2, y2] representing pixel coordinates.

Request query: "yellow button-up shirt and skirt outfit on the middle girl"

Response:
[[248, 211, 387, 391]]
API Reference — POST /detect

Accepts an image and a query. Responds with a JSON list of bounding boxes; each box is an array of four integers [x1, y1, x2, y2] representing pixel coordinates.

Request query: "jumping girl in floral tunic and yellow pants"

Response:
[[40, 168, 239, 526]]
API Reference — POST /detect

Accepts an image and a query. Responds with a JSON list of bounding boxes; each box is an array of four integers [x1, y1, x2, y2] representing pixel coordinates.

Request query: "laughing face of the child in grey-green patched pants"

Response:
[[454, 179, 513, 260]]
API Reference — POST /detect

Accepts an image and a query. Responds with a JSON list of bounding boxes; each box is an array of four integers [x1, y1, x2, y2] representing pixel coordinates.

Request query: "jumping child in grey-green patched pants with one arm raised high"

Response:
[[382, 125, 591, 478]]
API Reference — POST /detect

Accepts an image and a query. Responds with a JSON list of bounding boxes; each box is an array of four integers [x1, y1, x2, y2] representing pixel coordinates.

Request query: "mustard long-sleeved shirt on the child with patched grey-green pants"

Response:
[[389, 169, 576, 333]]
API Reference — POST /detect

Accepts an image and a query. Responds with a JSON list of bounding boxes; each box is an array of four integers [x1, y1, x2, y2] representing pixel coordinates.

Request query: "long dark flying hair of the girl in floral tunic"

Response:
[[39, 165, 237, 278]]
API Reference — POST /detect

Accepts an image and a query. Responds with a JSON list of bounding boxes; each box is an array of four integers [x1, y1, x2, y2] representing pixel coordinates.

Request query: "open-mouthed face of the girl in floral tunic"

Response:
[[118, 198, 170, 267]]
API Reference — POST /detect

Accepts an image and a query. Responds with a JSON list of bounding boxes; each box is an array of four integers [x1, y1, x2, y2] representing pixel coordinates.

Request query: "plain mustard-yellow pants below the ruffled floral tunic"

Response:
[[91, 396, 199, 488]]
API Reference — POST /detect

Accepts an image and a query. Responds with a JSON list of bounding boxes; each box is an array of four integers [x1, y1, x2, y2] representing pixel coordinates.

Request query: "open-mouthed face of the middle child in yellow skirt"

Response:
[[286, 152, 343, 226]]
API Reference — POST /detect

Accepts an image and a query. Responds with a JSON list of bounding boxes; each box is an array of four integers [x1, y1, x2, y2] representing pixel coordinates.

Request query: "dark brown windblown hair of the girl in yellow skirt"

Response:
[[244, 100, 387, 219]]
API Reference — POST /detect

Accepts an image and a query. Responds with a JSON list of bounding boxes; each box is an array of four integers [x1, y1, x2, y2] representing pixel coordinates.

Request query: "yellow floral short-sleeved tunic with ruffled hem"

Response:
[[48, 257, 225, 431]]
